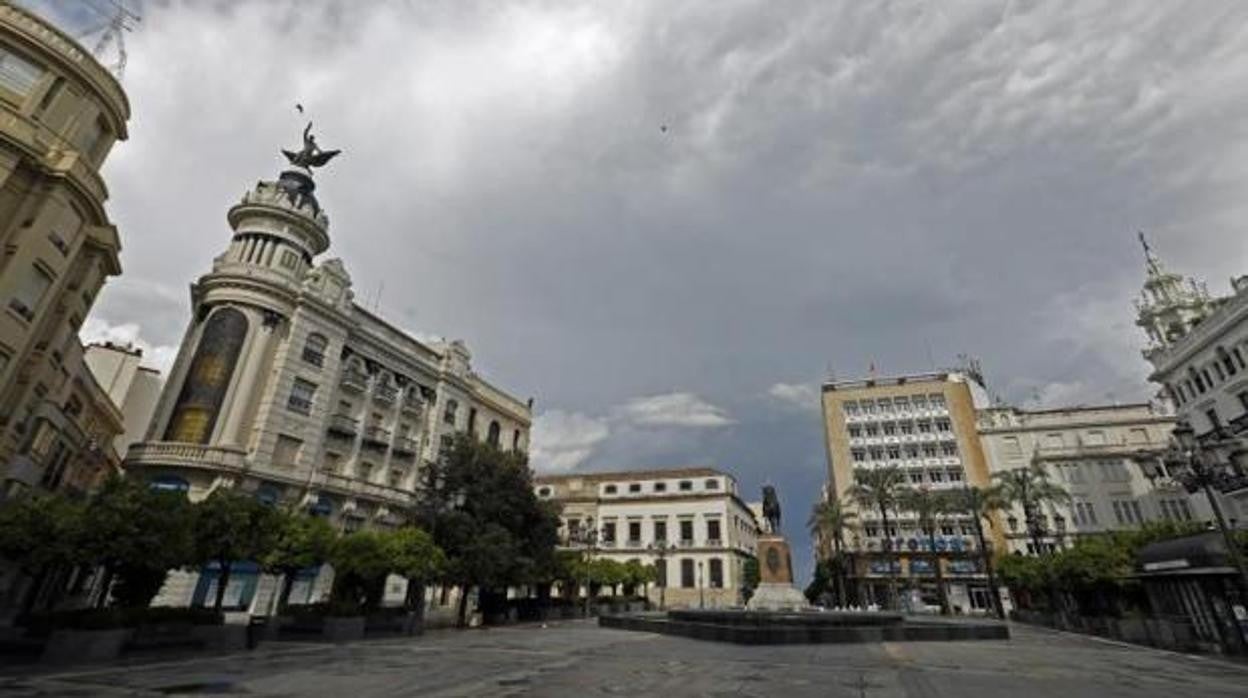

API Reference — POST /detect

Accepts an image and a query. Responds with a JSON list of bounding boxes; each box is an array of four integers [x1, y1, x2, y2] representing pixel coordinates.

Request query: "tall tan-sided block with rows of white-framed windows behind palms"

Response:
[[822, 371, 991, 612]]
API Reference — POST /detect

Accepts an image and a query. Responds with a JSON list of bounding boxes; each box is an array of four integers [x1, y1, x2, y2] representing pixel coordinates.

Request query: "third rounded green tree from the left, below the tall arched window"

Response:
[[192, 489, 281, 611]]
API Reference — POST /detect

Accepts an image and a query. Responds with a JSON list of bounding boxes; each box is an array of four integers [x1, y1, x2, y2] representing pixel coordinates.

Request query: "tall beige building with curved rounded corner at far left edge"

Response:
[[0, 4, 130, 496]]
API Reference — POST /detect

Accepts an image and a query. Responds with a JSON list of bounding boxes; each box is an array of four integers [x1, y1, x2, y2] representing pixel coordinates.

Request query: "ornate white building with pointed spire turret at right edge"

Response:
[[1136, 236, 1248, 524]]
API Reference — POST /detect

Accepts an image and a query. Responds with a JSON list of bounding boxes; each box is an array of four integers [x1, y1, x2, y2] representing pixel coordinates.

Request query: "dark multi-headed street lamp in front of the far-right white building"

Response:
[[1141, 420, 1248, 597]]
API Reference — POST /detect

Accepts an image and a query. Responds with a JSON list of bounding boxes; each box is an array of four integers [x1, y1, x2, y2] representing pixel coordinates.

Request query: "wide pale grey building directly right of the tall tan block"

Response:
[[978, 403, 1212, 554]]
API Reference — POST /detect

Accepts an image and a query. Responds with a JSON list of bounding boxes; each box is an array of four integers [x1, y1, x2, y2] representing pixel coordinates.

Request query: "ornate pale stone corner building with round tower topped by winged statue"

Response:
[[125, 133, 532, 604]]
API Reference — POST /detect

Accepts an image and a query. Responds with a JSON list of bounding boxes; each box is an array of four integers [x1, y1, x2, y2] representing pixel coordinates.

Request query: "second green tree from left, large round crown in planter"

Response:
[[77, 477, 193, 607]]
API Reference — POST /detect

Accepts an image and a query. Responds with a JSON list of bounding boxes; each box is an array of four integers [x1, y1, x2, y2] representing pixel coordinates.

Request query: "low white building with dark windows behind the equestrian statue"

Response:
[[534, 468, 759, 608]]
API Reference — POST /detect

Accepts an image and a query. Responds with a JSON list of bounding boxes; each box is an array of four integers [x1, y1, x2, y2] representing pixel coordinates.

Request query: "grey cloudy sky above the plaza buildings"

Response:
[[27, 0, 1248, 579]]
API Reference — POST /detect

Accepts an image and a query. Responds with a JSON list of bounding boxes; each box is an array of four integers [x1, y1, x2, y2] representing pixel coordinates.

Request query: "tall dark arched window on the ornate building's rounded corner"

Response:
[[165, 307, 248, 443]]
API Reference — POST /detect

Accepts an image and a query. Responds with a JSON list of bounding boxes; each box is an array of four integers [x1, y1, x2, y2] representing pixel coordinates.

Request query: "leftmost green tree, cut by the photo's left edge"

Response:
[[0, 494, 82, 611]]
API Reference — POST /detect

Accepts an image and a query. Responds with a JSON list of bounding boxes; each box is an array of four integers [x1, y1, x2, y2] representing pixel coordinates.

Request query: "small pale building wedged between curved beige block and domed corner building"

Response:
[[86, 342, 163, 455]]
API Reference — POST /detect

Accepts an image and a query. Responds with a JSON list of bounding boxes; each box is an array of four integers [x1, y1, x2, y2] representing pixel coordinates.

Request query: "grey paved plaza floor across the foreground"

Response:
[[0, 622, 1248, 698]]
